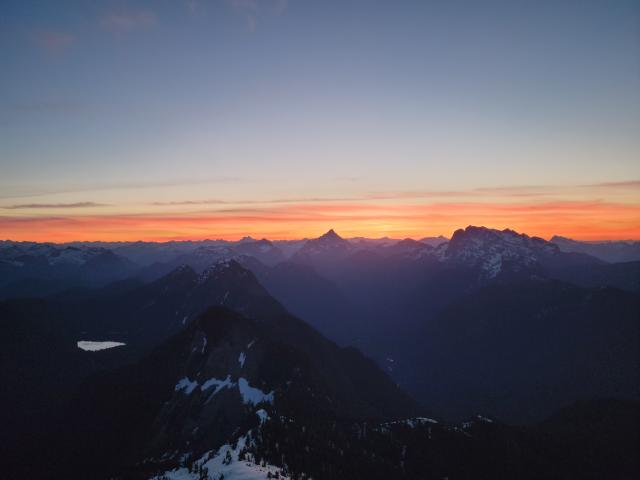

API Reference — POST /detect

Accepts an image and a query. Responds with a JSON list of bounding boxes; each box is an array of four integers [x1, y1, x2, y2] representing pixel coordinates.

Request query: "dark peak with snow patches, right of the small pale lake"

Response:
[[57, 307, 415, 474]]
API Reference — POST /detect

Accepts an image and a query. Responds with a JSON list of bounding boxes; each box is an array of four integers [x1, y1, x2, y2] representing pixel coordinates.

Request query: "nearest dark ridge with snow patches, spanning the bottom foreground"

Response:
[[10, 307, 640, 480]]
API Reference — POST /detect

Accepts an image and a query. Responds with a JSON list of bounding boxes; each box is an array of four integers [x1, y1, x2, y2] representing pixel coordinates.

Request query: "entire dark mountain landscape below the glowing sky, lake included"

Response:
[[0, 227, 640, 480]]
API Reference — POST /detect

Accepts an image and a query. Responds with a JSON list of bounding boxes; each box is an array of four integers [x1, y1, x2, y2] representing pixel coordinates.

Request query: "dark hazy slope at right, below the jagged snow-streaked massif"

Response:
[[408, 280, 640, 422]]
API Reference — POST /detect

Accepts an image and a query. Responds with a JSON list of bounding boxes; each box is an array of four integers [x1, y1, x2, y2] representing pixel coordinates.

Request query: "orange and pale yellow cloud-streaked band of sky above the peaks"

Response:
[[0, 182, 640, 242]]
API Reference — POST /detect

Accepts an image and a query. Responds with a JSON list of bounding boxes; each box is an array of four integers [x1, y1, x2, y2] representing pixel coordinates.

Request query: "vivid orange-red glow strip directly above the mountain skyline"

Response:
[[0, 201, 640, 243]]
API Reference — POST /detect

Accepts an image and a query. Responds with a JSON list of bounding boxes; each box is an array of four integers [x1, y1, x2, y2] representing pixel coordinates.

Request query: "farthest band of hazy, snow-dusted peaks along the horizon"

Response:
[[5, 226, 640, 286]]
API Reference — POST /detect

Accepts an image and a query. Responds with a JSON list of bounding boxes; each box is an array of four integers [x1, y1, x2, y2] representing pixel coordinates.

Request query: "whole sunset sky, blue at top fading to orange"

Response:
[[0, 0, 640, 242]]
